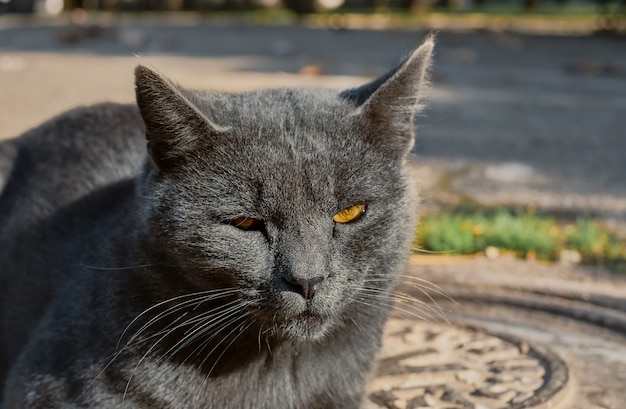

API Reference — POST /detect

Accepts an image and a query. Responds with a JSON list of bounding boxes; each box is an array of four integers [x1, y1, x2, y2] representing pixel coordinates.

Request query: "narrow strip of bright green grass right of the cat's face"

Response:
[[416, 208, 626, 273]]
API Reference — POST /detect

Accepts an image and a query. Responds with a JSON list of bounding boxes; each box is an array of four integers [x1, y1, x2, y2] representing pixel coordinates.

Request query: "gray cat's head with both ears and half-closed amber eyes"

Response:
[[136, 38, 433, 340]]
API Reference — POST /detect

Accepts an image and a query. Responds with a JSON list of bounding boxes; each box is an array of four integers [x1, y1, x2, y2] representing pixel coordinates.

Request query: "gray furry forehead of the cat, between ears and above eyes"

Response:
[[150, 88, 401, 211]]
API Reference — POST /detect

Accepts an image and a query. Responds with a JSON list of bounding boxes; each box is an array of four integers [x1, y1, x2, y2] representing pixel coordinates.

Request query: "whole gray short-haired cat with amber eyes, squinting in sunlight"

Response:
[[0, 38, 433, 409]]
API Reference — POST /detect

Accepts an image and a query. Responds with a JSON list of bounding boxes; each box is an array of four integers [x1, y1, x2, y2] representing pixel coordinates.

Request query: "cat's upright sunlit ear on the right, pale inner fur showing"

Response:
[[340, 35, 434, 158]]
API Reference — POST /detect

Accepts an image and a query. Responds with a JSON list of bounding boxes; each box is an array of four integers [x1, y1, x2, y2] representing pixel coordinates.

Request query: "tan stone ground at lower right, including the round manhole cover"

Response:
[[370, 257, 626, 409]]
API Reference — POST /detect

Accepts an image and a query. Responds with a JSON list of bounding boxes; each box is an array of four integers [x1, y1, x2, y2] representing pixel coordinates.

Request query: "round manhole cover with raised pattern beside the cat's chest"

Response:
[[366, 319, 568, 409]]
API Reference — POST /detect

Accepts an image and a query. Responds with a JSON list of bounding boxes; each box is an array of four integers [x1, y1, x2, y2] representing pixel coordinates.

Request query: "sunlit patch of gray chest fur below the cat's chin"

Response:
[[121, 352, 363, 409]]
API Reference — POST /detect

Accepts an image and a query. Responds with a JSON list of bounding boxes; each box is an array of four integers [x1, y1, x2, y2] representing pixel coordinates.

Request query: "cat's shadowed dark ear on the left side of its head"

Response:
[[135, 65, 226, 172]]
